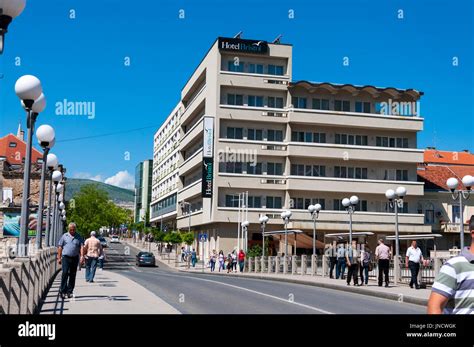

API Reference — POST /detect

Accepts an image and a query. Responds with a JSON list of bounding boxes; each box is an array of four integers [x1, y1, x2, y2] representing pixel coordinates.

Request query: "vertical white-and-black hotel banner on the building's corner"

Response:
[[202, 117, 214, 198]]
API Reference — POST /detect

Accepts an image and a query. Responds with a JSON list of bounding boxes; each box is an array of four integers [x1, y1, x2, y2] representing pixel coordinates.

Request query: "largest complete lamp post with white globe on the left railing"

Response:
[[15, 75, 46, 257]]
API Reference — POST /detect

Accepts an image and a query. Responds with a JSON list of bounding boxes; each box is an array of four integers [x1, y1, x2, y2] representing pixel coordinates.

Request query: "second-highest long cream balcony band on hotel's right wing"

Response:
[[288, 142, 423, 164]]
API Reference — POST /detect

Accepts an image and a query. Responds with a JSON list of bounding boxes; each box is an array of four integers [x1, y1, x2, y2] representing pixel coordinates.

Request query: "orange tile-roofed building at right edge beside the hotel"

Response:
[[417, 149, 474, 249]]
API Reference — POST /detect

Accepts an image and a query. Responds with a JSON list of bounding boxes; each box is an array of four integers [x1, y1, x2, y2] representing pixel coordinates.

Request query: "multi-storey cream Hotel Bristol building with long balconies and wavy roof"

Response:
[[152, 38, 431, 254]]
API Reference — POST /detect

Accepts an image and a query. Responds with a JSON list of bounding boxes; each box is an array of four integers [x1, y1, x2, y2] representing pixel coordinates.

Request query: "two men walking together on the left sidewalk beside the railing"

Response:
[[58, 223, 105, 299]]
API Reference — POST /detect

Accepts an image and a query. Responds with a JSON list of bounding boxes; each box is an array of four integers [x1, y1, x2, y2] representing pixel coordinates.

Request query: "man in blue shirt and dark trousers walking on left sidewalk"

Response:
[[58, 223, 84, 299]]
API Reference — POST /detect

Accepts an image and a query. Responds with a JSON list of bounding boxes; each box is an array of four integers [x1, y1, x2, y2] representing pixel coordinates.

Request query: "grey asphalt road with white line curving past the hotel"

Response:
[[104, 243, 426, 314]]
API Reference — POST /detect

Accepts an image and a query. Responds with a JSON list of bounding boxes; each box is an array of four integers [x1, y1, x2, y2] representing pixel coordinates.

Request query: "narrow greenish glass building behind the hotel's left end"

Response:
[[134, 159, 153, 223]]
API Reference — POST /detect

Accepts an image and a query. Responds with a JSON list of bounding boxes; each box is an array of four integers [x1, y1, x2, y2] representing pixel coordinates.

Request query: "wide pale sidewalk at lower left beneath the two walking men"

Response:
[[40, 269, 179, 314]]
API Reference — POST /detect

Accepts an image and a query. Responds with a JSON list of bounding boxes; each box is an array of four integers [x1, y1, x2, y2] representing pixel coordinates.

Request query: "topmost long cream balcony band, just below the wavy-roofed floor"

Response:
[[288, 108, 423, 131]]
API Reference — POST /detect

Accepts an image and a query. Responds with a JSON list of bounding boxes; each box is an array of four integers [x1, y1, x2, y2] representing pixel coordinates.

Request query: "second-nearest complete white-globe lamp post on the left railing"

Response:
[[36, 125, 55, 249]]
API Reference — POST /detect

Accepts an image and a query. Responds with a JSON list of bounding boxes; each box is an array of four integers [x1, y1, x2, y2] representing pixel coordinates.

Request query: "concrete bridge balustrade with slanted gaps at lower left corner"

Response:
[[0, 247, 59, 314]]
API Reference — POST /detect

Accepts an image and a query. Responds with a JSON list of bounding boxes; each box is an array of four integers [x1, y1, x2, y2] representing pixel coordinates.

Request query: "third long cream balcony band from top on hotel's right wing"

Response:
[[288, 176, 423, 196]]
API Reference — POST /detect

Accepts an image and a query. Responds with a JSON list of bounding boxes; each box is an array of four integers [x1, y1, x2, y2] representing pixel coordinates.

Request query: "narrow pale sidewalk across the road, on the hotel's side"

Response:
[[124, 239, 431, 306]]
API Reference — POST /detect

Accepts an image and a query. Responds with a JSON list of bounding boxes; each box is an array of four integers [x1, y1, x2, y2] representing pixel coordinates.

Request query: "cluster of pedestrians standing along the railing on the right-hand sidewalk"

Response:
[[329, 239, 424, 289]]
